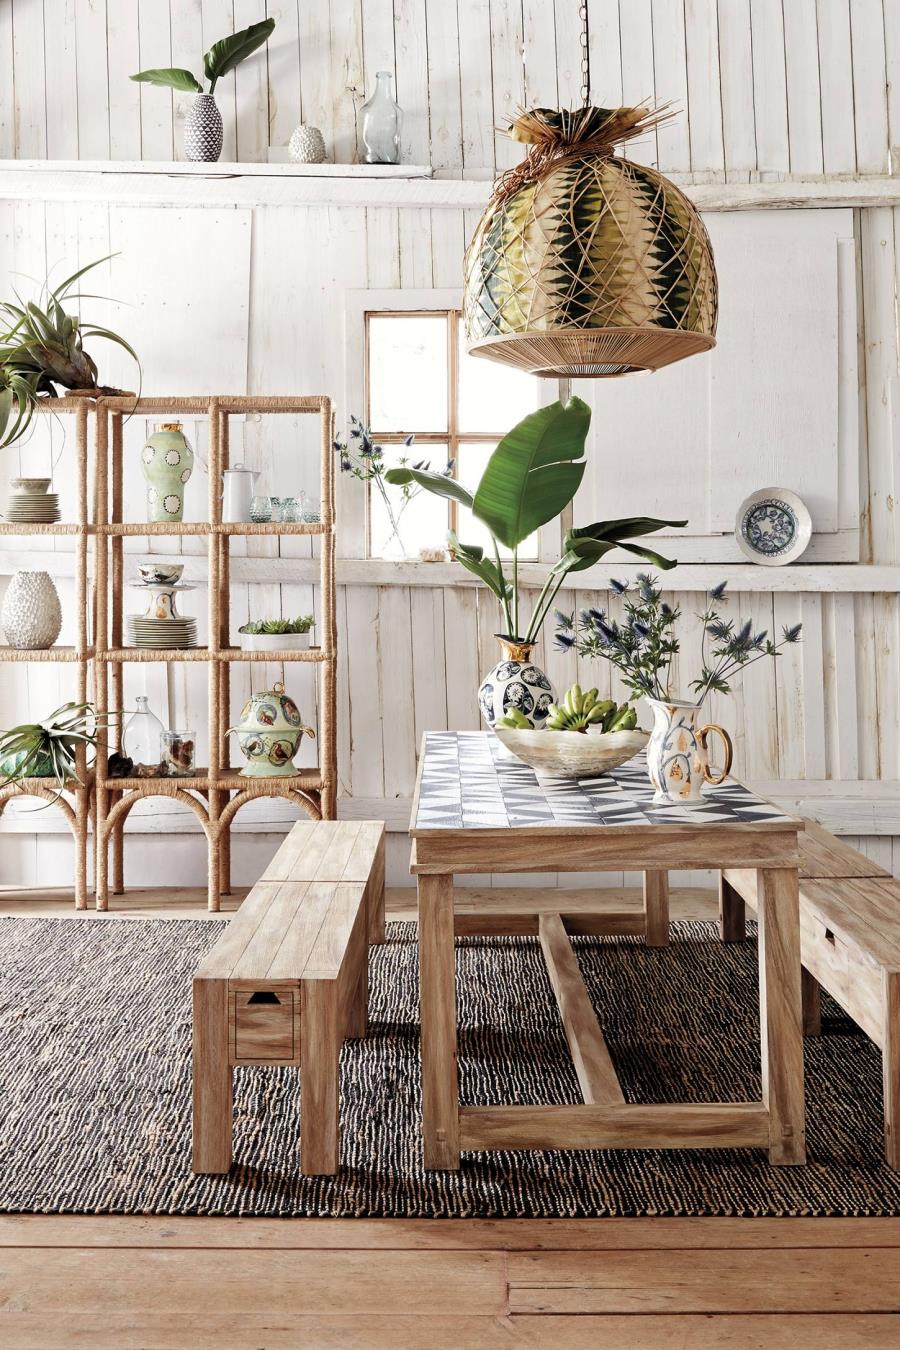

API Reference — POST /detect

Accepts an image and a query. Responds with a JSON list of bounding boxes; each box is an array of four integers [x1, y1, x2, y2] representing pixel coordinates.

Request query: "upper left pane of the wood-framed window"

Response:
[[368, 315, 447, 433]]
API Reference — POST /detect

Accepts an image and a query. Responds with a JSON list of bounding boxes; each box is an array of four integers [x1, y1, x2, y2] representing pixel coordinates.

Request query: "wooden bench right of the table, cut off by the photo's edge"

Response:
[[719, 821, 900, 1168]]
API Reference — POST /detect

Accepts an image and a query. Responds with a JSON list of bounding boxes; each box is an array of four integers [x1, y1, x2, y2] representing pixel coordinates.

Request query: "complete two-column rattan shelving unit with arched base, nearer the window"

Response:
[[94, 396, 337, 910]]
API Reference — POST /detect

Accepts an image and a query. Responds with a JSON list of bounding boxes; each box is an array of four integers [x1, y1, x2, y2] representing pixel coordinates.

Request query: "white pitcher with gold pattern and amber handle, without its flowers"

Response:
[[646, 698, 731, 806]]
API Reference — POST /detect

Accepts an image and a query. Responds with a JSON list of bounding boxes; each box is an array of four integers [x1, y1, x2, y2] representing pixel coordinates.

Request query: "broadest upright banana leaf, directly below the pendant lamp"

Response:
[[472, 397, 591, 548]]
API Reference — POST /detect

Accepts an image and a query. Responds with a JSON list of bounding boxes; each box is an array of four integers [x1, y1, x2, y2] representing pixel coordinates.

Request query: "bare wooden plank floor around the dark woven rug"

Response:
[[0, 891, 900, 1350]]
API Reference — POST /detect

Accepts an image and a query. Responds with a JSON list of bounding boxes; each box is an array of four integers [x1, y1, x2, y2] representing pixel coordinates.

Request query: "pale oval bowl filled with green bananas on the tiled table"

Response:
[[494, 684, 650, 778]]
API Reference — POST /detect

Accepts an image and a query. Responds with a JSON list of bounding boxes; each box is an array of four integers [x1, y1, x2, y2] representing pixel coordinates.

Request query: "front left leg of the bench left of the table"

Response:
[[193, 980, 232, 1172]]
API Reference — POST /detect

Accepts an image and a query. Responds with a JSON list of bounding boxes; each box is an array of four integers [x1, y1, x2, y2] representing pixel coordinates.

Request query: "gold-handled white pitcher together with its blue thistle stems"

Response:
[[556, 572, 801, 806]]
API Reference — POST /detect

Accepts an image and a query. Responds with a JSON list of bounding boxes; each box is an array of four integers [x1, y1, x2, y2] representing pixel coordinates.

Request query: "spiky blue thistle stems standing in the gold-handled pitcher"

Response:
[[556, 572, 803, 707]]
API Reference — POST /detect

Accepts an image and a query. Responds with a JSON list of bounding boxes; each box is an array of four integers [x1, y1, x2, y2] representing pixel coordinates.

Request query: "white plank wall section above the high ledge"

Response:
[[0, 0, 900, 181]]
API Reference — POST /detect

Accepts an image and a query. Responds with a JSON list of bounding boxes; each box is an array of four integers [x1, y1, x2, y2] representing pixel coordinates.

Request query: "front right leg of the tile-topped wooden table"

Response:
[[757, 867, 806, 1162]]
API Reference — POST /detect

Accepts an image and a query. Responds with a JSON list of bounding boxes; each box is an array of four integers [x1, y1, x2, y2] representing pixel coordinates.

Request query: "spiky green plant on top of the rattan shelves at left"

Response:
[[0, 254, 140, 446]]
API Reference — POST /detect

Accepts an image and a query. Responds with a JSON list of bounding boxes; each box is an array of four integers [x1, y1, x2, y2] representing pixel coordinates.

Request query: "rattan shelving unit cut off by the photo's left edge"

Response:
[[0, 394, 96, 910]]
